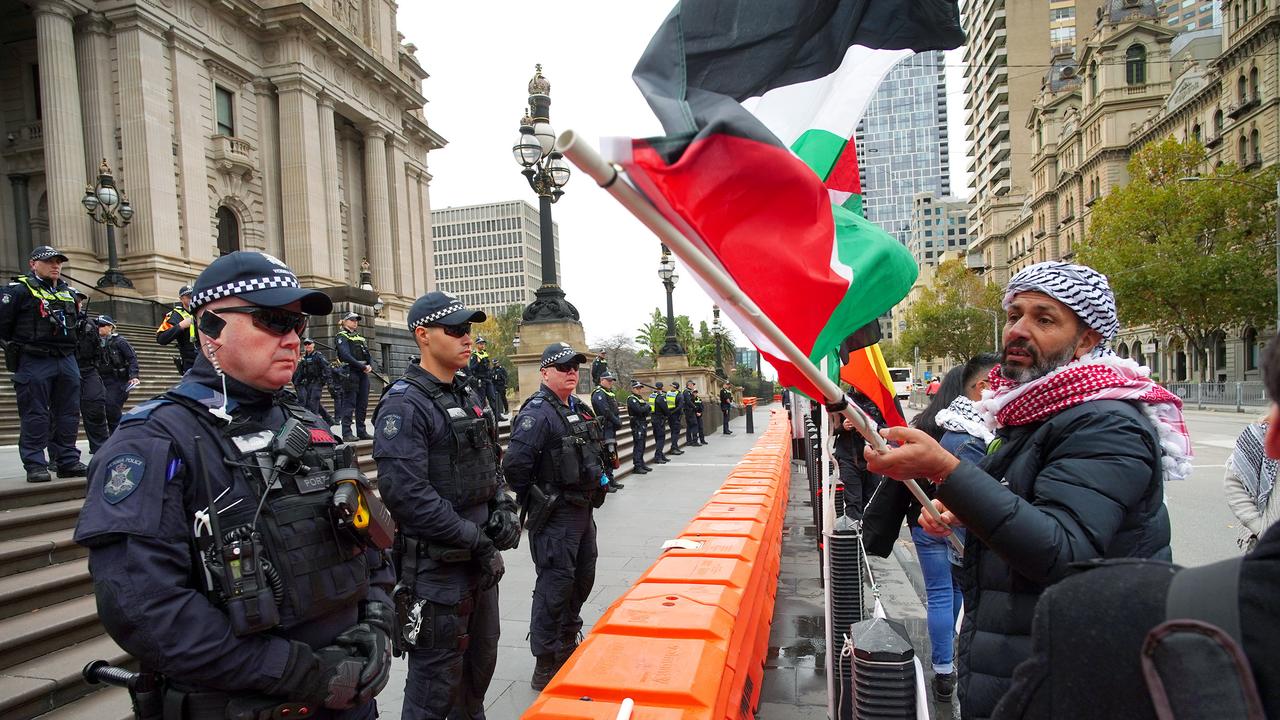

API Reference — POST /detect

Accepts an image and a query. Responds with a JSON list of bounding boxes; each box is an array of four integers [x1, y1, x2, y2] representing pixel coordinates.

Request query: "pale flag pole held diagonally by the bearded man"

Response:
[[557, 129, 964, 552]]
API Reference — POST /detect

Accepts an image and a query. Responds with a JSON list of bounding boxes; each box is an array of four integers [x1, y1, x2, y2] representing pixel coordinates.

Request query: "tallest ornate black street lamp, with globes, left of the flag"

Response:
[[511, 65, 580, 323]]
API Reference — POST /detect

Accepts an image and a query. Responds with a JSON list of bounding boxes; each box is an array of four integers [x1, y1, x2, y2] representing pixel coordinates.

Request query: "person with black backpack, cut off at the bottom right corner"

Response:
[[995, 338, 1280, 720]]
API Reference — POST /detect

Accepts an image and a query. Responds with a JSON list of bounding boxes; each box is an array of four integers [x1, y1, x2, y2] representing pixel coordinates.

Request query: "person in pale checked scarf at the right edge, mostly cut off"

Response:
[[1222, 419, 1280, 551]]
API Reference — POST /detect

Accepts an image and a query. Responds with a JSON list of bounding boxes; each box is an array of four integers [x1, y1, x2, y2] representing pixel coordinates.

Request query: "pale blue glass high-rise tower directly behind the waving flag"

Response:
[[855, 51, 951, 245]]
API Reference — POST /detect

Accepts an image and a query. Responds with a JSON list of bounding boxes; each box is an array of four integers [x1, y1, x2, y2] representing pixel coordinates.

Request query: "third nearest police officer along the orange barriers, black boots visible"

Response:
[[502, 342, 609, 691]]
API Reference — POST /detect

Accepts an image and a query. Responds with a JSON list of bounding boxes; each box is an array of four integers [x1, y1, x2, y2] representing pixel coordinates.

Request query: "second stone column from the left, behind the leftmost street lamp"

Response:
[[76, 13, 114, 263]]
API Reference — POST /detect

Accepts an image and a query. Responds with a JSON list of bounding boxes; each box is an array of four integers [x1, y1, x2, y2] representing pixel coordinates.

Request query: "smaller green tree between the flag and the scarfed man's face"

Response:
[[886, 260, 1004, 365]]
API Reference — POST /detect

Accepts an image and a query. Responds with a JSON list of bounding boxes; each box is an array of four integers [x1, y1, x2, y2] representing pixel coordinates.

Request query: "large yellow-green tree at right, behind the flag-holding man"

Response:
[[1076, 138, 1280, 380]]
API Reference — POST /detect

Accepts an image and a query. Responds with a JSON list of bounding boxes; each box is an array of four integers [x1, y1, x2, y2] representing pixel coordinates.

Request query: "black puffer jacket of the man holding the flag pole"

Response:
[[937, 400, 1171, 719]]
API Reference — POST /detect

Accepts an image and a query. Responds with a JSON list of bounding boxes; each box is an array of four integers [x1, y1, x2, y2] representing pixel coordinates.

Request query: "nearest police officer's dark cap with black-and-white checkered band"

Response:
[[191, 250, 333, 315]]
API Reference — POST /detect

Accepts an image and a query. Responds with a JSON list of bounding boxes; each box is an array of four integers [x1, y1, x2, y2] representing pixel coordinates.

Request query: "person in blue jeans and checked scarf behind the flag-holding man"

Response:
[[906, 354, 1000, 702]]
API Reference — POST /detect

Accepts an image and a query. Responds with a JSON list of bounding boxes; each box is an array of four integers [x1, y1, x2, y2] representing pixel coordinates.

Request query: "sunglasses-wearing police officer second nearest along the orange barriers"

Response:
[[374, 292, 521, 720]]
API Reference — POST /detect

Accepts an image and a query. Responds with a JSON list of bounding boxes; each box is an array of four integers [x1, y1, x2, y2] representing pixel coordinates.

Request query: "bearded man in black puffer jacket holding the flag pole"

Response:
[[867, 261, 1190, 717]]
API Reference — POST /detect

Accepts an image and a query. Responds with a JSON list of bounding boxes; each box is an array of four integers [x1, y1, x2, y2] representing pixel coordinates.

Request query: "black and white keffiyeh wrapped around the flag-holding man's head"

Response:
[[1004, 260, 1120, 346]]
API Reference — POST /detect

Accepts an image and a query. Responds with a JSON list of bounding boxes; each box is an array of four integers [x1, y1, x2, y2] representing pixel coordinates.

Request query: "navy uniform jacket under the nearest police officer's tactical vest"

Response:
[[76, 356, 394, 692]]
